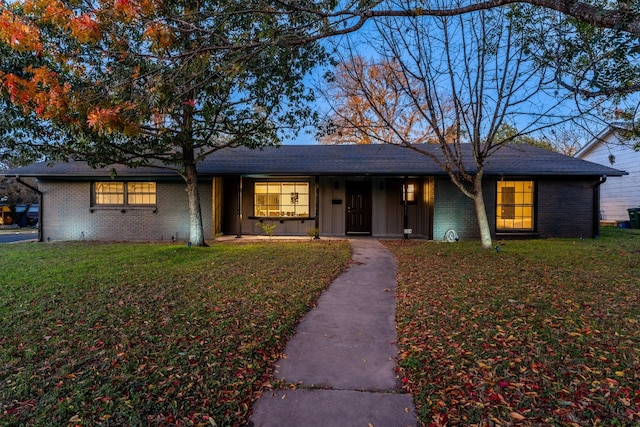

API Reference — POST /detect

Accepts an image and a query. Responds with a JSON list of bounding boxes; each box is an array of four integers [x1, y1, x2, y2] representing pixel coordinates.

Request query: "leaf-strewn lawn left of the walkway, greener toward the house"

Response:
[[0, 242, 350, 426]]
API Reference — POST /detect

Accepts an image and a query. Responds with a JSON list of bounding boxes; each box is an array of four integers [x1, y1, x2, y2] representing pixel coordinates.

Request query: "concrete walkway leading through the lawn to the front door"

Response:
[[249, 239, 417, 427]]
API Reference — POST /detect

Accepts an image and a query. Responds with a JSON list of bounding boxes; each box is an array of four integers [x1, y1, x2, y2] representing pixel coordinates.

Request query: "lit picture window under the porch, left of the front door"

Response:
[[254, 182, 309, 217]]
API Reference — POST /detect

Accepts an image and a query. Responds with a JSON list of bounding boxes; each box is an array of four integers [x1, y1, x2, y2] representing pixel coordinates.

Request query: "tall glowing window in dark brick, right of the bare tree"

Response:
[[496, 181, 534, 231]]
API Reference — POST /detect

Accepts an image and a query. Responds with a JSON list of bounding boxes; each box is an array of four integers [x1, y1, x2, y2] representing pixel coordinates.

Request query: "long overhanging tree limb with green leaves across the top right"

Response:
[[292, 0, 640, 113]]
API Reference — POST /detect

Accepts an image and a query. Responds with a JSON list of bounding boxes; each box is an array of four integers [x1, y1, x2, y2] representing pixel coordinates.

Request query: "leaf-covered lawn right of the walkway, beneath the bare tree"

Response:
[[386, 229, 640, 426]]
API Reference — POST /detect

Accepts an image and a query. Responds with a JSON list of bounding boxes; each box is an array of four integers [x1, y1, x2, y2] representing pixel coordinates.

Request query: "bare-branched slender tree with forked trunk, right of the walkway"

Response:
[[320, 9, 577, 248]]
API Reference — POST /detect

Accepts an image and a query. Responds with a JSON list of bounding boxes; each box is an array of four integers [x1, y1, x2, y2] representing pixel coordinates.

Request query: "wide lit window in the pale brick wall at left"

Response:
[[93, 181, 156, 206]]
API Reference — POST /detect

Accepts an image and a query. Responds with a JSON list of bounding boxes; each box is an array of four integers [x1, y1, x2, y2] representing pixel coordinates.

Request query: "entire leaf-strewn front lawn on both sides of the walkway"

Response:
[[0, 228, 640, 427]]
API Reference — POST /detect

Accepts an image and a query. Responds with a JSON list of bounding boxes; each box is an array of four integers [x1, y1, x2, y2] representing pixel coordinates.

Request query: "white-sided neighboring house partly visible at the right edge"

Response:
[[575, 126, 640, 224]]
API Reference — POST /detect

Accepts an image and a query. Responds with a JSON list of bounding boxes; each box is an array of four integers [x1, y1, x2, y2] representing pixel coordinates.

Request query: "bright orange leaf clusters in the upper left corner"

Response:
[[0, 0, 148, 134]]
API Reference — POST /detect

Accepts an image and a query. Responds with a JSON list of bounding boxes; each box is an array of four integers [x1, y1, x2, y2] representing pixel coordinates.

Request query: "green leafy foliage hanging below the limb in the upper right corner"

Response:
[[511, 2, 640, 98]]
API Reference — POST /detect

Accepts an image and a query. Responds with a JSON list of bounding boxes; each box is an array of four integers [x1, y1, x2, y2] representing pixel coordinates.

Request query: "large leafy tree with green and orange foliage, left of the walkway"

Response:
[[0, 0, 325, 245]]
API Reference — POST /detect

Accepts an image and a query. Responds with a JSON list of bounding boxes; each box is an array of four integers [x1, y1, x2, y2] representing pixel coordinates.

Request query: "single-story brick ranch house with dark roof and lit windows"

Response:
[[5, 144, 624, 241]]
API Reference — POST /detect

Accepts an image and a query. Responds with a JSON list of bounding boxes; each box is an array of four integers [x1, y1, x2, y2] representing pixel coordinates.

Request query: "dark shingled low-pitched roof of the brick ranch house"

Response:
[[7, 144, 626, 179]]
